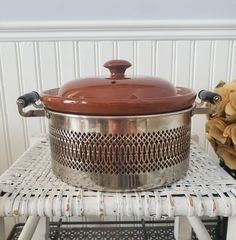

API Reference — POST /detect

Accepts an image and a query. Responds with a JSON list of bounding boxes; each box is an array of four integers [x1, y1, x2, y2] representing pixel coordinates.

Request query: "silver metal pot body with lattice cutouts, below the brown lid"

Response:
[[48, 108, 192, 192]]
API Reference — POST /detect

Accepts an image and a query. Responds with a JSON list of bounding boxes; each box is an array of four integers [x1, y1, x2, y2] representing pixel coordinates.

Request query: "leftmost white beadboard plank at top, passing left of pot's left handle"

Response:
[[0, 43, 25, 160]]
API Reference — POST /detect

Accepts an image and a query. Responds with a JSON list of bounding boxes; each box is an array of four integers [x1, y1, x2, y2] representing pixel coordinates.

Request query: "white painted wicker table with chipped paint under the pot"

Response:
[[0, 138, 236, 240]]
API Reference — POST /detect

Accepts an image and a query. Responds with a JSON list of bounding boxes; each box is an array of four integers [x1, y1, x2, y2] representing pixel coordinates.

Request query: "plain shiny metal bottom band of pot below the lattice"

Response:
[[52, 158, 189, 192]]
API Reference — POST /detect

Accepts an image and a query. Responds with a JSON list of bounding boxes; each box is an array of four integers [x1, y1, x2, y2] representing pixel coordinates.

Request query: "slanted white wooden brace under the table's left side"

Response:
[[18, 216, 40, 240]]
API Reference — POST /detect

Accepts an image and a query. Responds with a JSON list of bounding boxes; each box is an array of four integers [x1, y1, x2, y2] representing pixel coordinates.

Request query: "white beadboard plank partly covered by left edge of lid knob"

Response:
[[98, 41, 114, 75]]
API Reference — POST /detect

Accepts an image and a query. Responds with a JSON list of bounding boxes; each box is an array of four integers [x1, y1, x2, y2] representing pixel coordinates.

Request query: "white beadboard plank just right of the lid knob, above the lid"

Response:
[[137, 41, 152, 75]]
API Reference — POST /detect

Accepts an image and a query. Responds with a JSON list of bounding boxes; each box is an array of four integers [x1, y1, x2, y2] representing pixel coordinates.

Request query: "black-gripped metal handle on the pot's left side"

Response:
[[16, 91, 46, 117]]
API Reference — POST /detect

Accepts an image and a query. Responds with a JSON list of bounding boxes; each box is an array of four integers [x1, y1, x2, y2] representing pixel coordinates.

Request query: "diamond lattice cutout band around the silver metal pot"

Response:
[[50, 126, 190, 174]]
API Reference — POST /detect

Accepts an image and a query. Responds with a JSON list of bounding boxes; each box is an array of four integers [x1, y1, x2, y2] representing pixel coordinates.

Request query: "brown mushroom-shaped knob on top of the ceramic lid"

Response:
[[103, 60, 131, 79]]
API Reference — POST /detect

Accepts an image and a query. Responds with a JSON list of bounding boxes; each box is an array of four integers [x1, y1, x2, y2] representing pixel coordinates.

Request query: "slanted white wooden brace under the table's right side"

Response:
[[187, 216, 211, 240]]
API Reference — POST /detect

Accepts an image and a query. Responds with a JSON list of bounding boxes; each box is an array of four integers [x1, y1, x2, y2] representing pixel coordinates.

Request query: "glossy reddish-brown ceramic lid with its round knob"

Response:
[[41, 60, 196, 116]]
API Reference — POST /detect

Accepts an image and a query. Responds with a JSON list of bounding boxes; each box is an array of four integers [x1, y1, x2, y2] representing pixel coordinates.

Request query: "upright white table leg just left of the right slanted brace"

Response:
[[174, 216, 192, 240]]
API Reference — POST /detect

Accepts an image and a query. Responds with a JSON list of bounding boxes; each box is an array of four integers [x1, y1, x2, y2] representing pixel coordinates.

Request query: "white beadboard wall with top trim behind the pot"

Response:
[[0, 21, 236, 173]]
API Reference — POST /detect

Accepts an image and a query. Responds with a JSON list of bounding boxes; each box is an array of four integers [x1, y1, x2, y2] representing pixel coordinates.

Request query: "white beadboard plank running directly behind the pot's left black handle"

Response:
[[18, 42, 42, 144]]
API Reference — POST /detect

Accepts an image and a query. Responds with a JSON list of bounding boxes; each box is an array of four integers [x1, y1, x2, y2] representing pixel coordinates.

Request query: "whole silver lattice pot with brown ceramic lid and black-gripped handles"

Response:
[[17, 60, 221, 191]]
